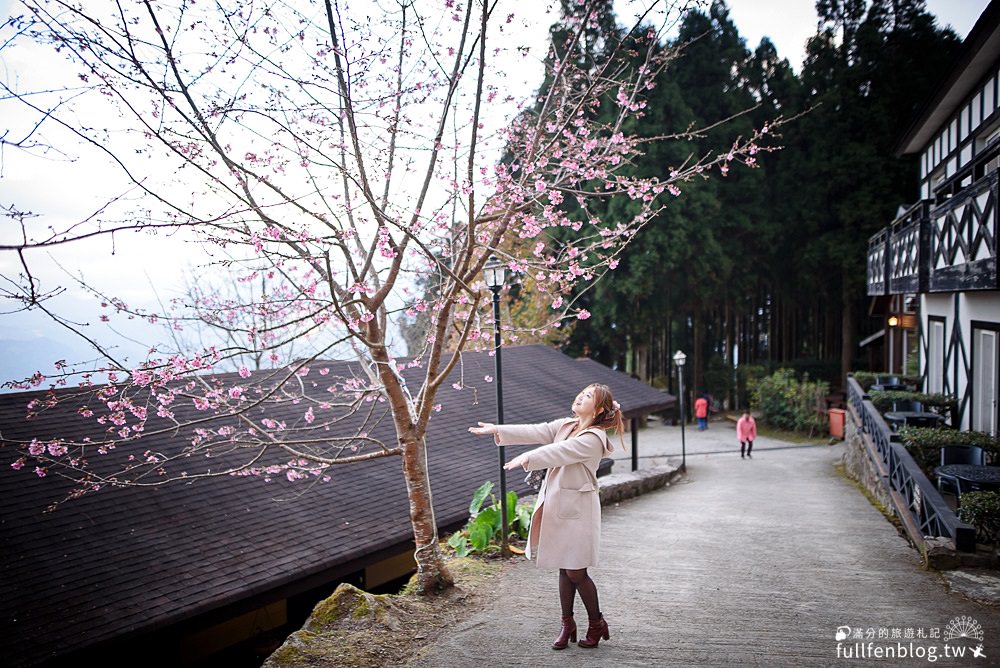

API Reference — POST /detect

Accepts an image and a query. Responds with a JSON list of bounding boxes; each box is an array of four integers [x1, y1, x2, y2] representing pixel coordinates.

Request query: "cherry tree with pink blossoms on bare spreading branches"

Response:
[[0, 0, 781, 591]]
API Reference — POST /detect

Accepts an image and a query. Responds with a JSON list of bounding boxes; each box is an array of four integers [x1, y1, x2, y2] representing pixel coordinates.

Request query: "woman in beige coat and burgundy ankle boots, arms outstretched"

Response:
[[469, 384, 625, 649]]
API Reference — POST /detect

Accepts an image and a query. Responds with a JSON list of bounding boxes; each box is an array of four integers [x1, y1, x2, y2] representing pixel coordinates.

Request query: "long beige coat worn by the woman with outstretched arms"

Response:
[[496, 418, 609, 569]]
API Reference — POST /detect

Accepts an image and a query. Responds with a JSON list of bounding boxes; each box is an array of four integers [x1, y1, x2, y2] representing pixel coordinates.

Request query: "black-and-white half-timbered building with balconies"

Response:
[[867, 0, 1000, 433]]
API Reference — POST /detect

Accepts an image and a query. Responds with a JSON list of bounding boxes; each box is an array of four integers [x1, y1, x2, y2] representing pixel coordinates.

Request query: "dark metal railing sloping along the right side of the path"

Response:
[[847, 377, 976, 552]]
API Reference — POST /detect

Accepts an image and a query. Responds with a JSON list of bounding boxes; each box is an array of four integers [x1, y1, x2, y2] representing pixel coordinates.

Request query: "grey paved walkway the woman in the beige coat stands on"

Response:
[[410, 422, 1000, 668]]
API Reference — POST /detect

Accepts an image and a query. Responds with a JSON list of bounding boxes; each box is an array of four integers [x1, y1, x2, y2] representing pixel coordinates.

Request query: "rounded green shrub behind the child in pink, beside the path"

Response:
[[751, 369, 830, 433]]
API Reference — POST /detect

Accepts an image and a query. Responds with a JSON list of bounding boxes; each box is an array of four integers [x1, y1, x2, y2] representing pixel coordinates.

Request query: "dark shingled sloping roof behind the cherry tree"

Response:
[[0, 345, 673, 666]]
